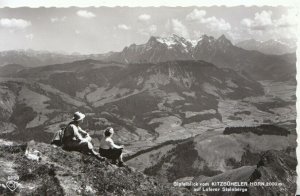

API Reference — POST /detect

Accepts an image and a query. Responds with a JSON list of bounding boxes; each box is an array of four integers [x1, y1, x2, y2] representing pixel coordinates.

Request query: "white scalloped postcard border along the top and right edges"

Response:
[[0, 0, 300, 195]]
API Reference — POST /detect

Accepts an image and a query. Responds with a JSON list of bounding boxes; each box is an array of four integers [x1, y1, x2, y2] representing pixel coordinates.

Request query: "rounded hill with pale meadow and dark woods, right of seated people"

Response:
[[135, 125, 296, 185]]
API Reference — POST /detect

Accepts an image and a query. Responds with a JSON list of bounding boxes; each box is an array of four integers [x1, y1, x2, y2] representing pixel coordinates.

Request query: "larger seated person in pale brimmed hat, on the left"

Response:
[[62, 112, 105, 161]]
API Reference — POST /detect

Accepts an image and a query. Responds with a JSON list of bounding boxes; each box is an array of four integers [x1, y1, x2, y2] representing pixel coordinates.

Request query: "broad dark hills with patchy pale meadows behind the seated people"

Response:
[[0, 60, 264, 153]]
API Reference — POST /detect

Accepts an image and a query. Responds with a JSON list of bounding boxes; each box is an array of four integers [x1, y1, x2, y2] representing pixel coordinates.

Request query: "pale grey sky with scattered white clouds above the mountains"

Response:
[[0, 5, 298, 54]]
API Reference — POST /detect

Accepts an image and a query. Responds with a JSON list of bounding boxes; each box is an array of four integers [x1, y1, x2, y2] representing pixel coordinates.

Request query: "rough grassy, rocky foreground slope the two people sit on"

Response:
[[0, 140, 191, 195]]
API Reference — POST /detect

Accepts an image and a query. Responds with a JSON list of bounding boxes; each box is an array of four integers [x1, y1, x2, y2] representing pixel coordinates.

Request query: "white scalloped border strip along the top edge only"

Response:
[[0, 0, 300, 8]]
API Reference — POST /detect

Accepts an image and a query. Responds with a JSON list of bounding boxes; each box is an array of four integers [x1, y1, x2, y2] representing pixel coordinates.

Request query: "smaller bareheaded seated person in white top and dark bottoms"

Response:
[[99, 127, 124, 167]]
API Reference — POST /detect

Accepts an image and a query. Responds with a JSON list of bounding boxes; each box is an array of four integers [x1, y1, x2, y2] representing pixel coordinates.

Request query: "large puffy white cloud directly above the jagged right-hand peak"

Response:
[[186, 9, 231, 31]]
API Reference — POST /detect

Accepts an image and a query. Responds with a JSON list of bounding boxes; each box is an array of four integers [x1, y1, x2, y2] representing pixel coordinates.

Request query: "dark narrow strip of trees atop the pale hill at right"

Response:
[[223, 125, 291, 136]]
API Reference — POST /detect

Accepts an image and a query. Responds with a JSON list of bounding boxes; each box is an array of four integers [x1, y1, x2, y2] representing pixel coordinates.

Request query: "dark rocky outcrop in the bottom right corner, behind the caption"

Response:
[[193, 150, 297, 196]]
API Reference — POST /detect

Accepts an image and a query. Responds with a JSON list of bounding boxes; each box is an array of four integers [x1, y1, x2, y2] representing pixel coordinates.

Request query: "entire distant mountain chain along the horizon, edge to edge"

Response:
[[0, 34, 296, 67]]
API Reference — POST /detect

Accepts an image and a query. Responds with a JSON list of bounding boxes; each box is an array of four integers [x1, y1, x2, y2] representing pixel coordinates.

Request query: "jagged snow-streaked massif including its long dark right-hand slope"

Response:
[[104, 34, 295, 80]]
